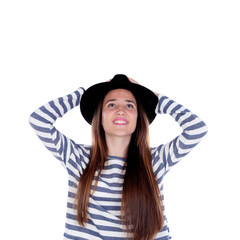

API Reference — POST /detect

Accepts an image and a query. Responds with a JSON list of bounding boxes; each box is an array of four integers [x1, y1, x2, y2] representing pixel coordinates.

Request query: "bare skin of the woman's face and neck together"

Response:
[[102, 89, 138, 157]]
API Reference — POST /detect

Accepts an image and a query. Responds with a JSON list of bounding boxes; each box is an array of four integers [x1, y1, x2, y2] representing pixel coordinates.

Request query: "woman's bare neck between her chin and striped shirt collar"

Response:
[[106, 136, 131, 157]]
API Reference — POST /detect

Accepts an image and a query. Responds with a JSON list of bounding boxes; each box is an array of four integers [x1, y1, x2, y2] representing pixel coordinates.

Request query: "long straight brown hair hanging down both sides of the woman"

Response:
[[75, 95, 164, 240]]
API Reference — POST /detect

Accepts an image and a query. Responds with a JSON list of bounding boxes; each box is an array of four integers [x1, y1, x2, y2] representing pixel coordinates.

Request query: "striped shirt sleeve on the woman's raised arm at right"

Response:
[[152, 95, 207, 183]]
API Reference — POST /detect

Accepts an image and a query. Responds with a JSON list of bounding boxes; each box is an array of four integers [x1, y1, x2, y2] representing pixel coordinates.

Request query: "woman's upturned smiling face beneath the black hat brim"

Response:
[[102, 89, 138, 137]]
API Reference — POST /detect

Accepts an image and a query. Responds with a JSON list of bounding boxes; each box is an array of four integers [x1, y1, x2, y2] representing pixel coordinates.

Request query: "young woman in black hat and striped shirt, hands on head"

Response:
[[29, 74, 207, 240]]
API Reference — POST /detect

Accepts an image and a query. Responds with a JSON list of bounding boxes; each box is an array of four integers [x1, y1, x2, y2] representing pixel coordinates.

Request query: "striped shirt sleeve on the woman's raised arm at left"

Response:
[[29, 88, 90, 172]]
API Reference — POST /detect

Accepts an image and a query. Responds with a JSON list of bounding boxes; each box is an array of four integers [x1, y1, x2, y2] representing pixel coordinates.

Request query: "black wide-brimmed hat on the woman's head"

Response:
[[80, 74, 158, 124]]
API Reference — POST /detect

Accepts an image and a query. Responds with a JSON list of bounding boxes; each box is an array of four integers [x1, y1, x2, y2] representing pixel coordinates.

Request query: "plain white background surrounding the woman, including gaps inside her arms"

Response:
[[0, 0, 240, 240]]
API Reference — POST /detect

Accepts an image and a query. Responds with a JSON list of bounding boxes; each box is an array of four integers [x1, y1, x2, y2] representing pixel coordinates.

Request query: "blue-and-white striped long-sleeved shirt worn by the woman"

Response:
[[29, 88, 207, 240]]
